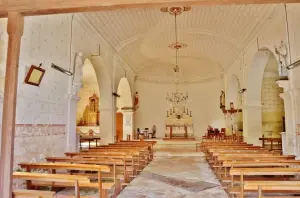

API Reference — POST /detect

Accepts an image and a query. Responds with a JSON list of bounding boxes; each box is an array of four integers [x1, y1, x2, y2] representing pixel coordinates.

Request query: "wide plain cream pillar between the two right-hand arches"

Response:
[[243, 104, 262, 146]]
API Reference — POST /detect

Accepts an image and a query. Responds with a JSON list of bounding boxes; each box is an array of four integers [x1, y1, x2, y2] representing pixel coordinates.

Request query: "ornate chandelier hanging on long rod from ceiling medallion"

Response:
[[161, 7, 191, 119]]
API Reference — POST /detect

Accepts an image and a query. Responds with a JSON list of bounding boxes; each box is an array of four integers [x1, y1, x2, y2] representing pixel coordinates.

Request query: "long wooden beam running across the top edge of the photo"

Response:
[[0, 0, 300, 17]]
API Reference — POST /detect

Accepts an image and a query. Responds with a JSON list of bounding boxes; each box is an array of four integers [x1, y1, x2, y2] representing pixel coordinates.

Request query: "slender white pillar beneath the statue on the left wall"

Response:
[[66, 91, 80, 152]]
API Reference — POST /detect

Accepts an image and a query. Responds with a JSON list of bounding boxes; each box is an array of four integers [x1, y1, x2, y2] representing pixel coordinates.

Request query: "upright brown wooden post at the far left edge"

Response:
[[0, 12, 24, 198]]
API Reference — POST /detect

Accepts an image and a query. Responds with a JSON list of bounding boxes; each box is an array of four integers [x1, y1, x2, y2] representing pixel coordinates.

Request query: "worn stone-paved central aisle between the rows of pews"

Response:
[[118, 140, 228, 198]]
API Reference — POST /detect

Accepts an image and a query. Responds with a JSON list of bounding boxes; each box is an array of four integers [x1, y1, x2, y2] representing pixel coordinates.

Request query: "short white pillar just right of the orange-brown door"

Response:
[[122, 108, 134, 140]]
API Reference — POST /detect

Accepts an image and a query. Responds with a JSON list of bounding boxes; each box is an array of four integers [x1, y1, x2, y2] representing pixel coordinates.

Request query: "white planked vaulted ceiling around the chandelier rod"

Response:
[[79, 5, 276, 82]]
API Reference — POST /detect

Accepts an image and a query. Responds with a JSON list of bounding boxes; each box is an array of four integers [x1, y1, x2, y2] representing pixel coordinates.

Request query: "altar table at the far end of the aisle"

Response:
[[164, 114, 194, 140]]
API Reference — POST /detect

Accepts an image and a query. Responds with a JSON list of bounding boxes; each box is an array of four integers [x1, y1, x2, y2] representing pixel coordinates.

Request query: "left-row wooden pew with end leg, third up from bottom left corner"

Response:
[[19, 163, 115, 197]]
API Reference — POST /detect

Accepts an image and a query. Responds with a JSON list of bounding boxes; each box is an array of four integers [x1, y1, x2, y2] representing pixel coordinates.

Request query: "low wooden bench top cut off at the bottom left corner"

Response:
[[12, 189, 55, 198]]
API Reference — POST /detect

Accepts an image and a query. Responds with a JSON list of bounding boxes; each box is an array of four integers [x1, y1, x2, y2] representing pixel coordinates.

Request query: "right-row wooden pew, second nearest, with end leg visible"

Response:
[[229, 168, 300, 198]]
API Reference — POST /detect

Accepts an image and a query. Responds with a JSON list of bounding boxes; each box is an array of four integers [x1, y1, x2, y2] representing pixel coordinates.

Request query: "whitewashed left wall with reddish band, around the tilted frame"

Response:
[[0, 15, 70, 165]]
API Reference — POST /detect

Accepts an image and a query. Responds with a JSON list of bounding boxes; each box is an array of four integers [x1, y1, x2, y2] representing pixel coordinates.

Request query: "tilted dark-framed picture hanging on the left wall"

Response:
[[24, 65, 45, 86]]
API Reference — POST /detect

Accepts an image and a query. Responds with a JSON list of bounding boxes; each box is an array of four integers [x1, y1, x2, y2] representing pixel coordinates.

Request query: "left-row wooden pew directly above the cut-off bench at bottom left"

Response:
[[13, 172, 90, 198]]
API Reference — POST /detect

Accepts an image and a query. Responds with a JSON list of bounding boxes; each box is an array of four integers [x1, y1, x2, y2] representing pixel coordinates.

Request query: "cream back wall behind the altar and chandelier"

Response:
[[135, 80, 225, 138]]
